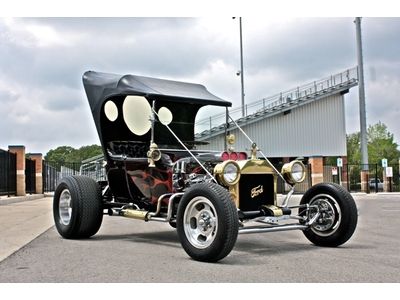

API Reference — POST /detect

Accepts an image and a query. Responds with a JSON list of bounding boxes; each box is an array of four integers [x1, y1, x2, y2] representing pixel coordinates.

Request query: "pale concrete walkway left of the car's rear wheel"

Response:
[[0, 195, 54, 261]]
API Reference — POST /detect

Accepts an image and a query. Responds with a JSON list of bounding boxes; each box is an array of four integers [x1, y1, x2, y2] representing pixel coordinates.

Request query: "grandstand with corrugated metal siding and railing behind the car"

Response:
[[196, 68, 358, 158]]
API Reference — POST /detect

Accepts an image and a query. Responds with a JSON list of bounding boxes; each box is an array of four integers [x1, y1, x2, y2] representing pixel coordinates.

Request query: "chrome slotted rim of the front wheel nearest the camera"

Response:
[[183, 196, 218, 249]]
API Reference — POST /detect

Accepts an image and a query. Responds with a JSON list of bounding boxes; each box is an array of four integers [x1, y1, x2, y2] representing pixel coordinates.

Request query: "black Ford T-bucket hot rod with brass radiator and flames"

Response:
[[53, 71, 357, 262]]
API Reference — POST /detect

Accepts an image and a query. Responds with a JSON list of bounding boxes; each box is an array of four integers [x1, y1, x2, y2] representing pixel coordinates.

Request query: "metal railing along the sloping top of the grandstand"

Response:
[[195, 67, 358, 133]]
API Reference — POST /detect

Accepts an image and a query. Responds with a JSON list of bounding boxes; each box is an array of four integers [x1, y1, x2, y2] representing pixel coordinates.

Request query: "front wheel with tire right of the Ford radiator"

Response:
[[299, 183, 358, 247]]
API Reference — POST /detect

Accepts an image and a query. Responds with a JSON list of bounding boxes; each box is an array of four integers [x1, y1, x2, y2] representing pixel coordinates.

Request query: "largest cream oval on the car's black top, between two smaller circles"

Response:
[[122, 96, 151, 135]]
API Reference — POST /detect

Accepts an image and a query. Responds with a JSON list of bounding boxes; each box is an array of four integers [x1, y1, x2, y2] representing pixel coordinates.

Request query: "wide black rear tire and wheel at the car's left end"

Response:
[[53, 176, 103, 239]]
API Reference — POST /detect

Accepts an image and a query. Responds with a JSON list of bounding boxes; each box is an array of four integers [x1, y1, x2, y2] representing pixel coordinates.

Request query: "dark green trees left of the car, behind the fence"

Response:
[[44, 145, 103, 163]]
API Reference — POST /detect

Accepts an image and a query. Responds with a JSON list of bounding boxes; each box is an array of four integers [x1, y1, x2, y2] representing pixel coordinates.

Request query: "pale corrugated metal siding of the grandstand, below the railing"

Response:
[[198, 94, 347, 157]]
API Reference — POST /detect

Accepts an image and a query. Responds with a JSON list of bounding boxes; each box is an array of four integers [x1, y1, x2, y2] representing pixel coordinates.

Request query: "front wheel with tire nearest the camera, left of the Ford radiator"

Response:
[[176, 183, 239, 262]]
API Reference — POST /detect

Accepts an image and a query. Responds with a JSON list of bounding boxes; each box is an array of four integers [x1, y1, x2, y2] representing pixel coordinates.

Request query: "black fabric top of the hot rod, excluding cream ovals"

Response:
[[83, 71, 232, 148]]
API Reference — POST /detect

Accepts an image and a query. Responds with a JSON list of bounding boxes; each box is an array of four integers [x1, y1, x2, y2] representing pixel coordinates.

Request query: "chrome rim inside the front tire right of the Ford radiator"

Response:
[[310, 194, 342, 236]]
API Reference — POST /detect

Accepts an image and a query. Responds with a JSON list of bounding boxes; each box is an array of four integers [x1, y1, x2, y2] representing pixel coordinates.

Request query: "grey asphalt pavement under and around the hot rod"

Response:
[[0, 193, 400, 283]]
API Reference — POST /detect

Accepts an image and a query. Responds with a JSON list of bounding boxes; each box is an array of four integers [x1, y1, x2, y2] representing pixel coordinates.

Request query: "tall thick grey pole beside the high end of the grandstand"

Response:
[[354, 17, 369, 190]]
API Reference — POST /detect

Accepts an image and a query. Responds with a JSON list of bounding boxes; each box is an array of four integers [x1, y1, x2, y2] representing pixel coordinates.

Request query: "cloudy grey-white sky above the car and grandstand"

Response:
[[0, 16, 400, 154]]
